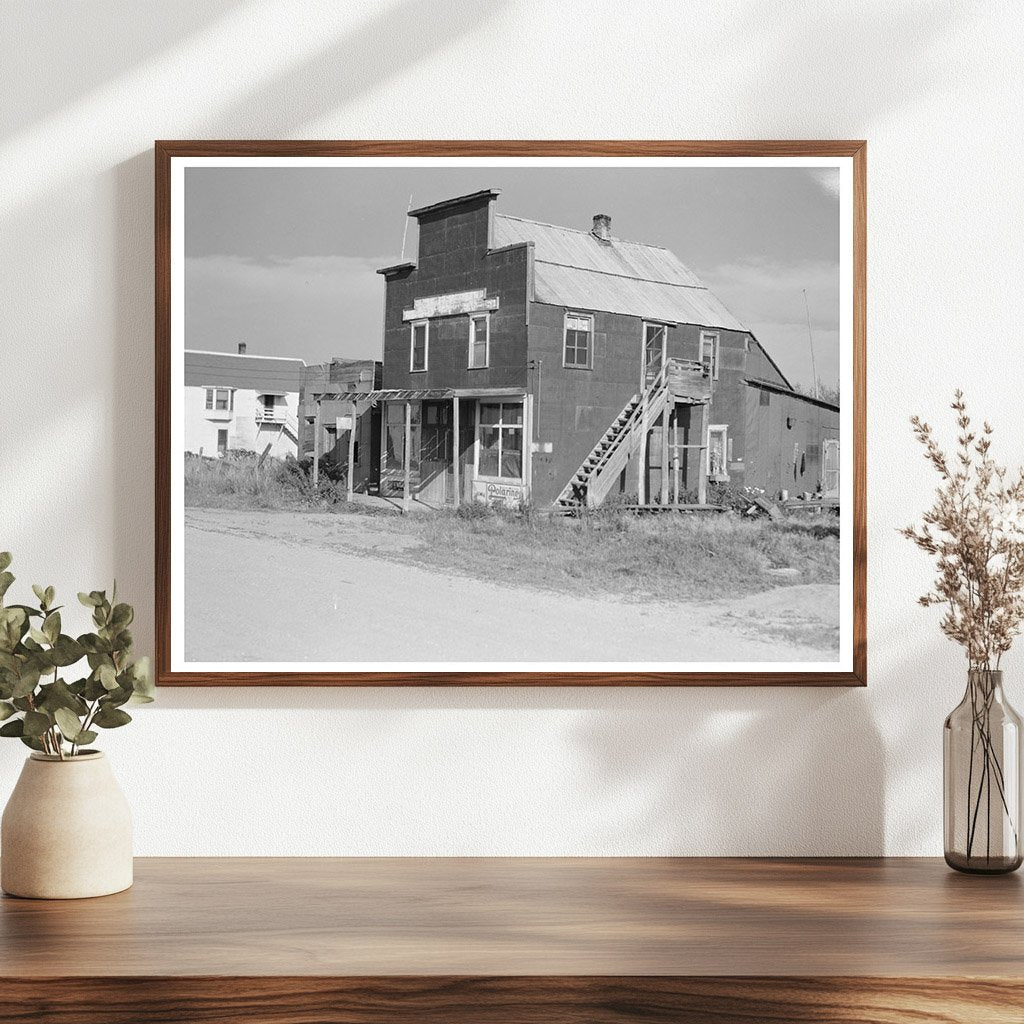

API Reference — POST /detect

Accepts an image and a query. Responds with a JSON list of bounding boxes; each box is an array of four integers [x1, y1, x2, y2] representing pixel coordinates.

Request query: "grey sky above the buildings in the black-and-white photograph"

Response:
[[185, 167, 839, 384]]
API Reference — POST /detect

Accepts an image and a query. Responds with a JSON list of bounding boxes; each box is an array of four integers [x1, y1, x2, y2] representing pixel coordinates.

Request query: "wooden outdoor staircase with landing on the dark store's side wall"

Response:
[[555, 359, 711, 512]]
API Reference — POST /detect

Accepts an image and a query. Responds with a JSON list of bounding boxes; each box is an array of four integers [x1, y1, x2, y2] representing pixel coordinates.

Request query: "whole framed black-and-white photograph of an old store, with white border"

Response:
[[156, 141, 866, 686]]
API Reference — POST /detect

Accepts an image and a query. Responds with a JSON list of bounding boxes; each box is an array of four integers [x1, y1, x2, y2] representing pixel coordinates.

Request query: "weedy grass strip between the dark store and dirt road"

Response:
[[184, 453, 839, 600]]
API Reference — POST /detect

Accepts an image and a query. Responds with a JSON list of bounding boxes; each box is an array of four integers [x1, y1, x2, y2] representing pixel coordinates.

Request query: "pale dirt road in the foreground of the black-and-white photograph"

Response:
[[184, 508, 839, 664]]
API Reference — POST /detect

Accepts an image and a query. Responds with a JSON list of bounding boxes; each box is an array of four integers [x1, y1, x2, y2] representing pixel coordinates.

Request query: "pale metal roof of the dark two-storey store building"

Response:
[[494, 214, 746, 331]]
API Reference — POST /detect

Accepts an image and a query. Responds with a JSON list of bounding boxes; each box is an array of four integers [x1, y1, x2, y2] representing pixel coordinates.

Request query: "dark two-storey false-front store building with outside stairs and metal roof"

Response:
[[323, 189, 839, 507]]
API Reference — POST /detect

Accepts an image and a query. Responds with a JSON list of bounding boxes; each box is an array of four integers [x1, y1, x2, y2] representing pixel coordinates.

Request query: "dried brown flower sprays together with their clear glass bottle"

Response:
[[901, 389, 1024, 871]]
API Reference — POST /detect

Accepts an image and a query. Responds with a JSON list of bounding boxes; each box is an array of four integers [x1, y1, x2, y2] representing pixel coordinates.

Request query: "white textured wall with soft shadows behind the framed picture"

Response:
[[0, 0, 1024, 854]]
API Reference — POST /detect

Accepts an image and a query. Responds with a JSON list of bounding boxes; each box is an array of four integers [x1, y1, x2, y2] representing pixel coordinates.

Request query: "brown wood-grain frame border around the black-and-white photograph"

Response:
[[154, 139, 867, 686]]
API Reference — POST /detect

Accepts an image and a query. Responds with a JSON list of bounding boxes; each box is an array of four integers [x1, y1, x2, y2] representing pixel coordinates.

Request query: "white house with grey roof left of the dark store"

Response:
[[183, 344, 305, 459]]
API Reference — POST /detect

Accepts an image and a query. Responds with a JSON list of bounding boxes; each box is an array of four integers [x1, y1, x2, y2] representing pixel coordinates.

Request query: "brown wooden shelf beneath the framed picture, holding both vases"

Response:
[[0, 858, 1024, 1024]]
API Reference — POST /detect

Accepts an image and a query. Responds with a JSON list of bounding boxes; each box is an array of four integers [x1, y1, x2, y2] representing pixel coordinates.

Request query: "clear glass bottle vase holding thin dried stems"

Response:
[[942, 669, 1021, 874]]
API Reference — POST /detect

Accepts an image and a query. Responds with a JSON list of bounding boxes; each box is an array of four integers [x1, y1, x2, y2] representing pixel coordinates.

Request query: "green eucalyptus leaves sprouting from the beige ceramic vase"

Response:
[[0, 551, 154, 760]]
